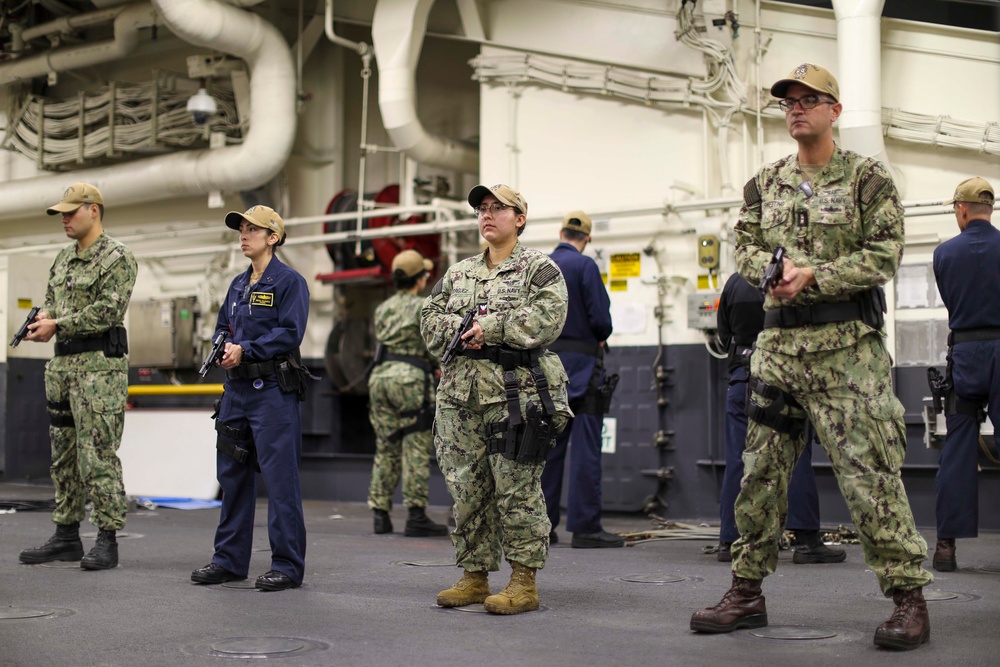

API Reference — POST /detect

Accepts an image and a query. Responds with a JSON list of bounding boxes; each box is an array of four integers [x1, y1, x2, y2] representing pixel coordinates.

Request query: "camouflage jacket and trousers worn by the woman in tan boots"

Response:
[[420, 243, 572, 570]]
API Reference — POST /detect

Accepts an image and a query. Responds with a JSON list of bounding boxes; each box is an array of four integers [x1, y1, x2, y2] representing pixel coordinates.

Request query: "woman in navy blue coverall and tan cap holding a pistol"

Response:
[[191, 206, 309, 591]]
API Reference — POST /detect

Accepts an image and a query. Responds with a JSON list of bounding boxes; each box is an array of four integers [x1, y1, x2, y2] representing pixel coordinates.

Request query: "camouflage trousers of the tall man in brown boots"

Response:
[[732, 334, 934, 595]]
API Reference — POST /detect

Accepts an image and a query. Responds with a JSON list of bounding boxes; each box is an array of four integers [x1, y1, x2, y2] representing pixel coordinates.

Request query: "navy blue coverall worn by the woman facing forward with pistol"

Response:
[[212, 257, 309, 585]]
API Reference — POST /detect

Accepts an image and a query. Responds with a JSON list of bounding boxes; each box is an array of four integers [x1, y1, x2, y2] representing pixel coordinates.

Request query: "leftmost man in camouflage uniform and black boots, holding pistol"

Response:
[[21, 183, 137, 570]]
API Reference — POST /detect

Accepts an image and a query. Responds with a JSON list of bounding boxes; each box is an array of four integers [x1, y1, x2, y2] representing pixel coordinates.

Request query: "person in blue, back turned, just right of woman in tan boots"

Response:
[[542, 211, 624, 548]]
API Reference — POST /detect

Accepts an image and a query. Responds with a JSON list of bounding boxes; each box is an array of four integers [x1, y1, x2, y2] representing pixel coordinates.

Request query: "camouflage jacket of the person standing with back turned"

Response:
[[371, 292, 436, 397]]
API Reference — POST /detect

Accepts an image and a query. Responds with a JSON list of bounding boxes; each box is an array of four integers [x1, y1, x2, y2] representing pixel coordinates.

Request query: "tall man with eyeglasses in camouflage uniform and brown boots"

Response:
[[691, 63, 934, 650]]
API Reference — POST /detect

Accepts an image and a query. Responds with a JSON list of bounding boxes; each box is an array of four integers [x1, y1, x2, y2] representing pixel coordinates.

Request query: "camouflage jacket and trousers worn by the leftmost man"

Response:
[[42, 233, 137, 530]]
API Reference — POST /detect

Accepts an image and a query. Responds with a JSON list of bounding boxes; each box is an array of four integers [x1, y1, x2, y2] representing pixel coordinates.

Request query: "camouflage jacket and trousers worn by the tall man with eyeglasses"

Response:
[[732, 147, 933, 594]]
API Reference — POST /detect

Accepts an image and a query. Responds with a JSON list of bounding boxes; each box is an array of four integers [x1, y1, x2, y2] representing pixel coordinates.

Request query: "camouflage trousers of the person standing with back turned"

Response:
[[368, 375, 434, 512]]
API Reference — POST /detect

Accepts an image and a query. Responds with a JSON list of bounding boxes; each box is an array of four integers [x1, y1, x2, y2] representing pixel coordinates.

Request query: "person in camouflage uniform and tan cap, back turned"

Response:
[[368, 250, 448, 537]]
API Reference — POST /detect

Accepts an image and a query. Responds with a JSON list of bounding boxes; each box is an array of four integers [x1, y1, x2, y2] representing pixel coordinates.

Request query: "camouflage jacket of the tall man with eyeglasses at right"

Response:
[[736, 146, 903, 354]]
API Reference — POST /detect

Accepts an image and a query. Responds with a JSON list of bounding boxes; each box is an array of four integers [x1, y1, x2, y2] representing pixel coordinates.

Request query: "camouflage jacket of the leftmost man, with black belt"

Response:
[[42, 233, 138, 371]]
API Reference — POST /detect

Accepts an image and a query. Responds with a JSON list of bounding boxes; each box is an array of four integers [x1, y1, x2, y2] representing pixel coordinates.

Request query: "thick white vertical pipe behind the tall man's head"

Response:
[[833, 0, 890, 167]]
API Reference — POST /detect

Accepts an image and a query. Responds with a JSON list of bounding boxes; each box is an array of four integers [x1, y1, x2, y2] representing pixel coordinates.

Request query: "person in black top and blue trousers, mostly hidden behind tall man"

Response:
[[717, 273, 847, 564]]
